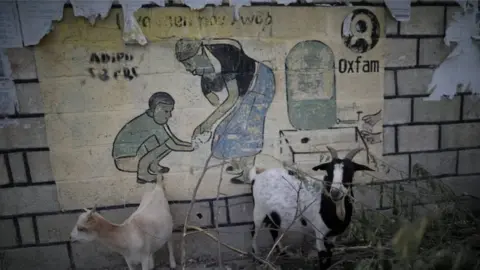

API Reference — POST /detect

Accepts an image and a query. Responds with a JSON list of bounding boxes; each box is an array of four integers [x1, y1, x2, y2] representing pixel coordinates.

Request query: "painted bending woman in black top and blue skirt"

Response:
[[175, 39, 275, 181]]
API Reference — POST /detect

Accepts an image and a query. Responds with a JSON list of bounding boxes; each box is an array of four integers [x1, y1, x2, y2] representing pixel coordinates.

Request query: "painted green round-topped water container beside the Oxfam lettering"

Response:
[[285, 40, 337, 130]]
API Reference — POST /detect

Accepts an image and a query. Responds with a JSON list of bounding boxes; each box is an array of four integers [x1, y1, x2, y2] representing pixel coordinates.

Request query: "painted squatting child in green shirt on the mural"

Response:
[[112, 92, 197, 184]]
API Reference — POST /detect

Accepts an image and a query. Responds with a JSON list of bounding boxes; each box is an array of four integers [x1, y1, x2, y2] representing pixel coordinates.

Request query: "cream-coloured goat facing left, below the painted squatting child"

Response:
[[70, 177, 176, 270]]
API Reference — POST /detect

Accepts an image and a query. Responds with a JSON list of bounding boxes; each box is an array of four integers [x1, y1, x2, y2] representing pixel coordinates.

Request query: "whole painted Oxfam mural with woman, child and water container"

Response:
[[35, 7, 384, 209]]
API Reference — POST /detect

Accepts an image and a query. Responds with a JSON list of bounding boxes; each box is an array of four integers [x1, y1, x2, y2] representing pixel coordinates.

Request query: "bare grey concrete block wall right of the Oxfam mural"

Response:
[[384, 3, 480, 202]]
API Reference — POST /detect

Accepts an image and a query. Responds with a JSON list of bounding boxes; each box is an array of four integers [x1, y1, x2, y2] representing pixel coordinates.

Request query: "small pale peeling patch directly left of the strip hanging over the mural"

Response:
[[70, 0, 113, 25]]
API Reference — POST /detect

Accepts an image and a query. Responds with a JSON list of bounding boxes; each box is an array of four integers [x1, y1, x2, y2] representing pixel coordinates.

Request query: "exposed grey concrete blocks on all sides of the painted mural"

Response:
[[0, 1, 480, 270]]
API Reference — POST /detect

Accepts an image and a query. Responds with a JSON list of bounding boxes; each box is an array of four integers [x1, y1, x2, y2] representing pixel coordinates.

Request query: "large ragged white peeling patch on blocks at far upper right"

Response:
[[425, 1, 480, 100]]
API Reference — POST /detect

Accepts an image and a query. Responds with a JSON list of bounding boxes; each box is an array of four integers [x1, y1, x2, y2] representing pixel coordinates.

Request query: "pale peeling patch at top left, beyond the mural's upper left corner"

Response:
[[17, 0, 66, 46]]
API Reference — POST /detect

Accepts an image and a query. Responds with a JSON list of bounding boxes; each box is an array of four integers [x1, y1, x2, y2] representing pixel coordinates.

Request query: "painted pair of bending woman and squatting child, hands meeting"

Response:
[[112, 39, 275, 183]]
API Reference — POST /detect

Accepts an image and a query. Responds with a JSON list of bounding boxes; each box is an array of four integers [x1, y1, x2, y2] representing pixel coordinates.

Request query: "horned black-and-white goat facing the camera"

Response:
[[249, 146, 373, 269]]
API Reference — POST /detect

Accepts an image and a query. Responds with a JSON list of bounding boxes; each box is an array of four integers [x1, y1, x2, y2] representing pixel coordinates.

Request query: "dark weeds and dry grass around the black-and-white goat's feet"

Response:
[[182, 154, 480, 270]]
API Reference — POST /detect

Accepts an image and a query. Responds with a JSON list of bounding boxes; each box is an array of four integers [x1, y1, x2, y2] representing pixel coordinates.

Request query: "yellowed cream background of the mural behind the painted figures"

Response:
[[35, 7, 384, 209]]
